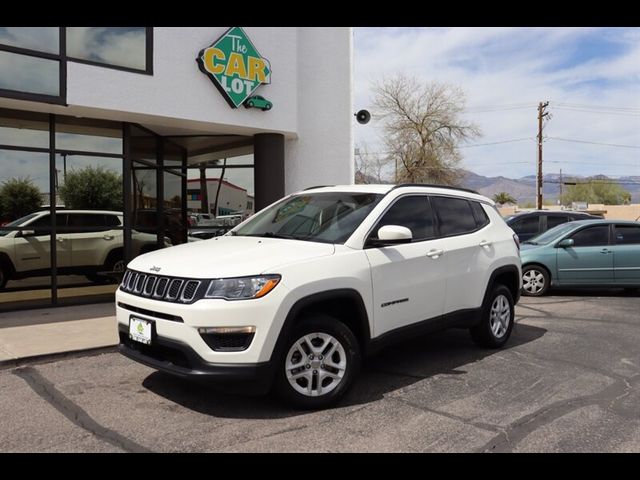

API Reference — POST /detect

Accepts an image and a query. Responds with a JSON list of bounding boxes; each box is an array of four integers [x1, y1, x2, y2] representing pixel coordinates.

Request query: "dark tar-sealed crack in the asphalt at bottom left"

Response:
[[12, 367, 151, 453]]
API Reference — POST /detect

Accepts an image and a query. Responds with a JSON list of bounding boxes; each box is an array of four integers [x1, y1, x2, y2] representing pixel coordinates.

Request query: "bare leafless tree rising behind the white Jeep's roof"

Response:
[[374, 74, 481, 185]]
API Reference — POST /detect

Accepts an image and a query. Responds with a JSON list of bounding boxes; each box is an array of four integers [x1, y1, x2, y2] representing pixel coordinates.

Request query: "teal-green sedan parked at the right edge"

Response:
[[520, 220, 640, 296]]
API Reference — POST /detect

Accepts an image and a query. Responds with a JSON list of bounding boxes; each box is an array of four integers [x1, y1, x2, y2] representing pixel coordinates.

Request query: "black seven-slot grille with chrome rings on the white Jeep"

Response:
[[120, 270, 204, 303]]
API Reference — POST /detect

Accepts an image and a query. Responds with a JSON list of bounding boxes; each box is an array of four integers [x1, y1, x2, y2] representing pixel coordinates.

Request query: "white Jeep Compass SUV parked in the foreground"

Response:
[[116, 185, 521, 408]]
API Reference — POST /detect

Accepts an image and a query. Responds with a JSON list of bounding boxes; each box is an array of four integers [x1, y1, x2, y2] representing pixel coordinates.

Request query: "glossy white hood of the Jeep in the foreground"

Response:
[[128, 236, 335, 278]]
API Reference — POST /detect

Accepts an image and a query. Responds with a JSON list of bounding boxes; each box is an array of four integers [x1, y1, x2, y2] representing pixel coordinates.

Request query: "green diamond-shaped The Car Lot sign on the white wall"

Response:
[[196, 27, 272, 110]]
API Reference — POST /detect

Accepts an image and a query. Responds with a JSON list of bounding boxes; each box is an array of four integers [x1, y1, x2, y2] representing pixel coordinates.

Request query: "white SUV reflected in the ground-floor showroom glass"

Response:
[[0, 210, 170, 289]]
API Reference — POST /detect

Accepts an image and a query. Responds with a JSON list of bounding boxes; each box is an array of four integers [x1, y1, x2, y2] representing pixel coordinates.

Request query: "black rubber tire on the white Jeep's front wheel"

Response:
[[274, 314, 362, 410]]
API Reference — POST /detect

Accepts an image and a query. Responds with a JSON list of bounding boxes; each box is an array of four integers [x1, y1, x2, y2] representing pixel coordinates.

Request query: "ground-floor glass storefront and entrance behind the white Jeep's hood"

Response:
[[0, 109, 284, 311]]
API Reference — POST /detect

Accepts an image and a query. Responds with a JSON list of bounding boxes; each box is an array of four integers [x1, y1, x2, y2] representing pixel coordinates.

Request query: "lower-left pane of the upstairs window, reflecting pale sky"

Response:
[[0, 51, 60, 97]]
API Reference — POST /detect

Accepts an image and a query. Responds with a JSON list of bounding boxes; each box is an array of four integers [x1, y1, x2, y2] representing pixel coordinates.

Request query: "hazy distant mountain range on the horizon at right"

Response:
[[461, 170, 640, 204]]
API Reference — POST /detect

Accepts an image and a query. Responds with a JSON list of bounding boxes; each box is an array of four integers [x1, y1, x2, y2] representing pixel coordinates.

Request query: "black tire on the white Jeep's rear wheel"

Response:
[[469, 284, 515, 348]]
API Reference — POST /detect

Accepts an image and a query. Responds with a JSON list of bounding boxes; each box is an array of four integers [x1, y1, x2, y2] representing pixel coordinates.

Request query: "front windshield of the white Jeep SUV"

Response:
[[230, 192, 382, 243]]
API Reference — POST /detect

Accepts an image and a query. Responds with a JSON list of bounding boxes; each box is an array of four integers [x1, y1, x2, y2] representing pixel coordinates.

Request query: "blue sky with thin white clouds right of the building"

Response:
[[354, 27, 640, 178]]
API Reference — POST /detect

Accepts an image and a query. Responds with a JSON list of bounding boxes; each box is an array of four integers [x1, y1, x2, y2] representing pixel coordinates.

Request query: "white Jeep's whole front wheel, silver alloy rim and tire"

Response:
[[276, 315, 361, 409]]
